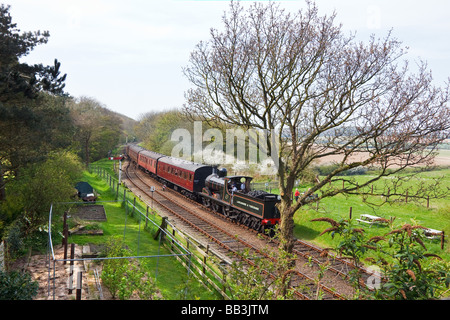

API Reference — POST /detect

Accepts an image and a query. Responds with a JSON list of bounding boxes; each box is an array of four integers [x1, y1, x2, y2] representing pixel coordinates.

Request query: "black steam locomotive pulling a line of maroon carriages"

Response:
[[125, 144, 280, 232]]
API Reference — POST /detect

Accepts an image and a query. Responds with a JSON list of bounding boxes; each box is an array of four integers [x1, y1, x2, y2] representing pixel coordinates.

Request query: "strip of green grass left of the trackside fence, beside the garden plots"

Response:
[[69, 165, 217, 300]]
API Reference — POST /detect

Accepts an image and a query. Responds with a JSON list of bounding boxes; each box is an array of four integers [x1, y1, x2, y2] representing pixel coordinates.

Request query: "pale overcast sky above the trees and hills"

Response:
[[7, 0, 450, 119]]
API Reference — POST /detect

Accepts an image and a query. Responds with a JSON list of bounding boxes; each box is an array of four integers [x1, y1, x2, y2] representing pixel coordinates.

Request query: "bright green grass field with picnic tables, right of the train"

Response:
[[294, 169, 450, 261]]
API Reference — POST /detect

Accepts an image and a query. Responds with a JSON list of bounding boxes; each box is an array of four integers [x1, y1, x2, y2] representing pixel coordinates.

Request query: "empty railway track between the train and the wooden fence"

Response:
[[125, 165, 352, 300]]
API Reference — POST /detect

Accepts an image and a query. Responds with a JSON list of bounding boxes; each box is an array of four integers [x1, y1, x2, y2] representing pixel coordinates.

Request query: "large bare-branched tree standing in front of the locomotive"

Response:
[[184, 2, 450, 252]]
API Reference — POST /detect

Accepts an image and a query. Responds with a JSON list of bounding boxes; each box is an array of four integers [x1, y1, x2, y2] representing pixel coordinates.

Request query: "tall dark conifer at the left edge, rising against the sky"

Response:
[[0, 4, 66, 200]]
